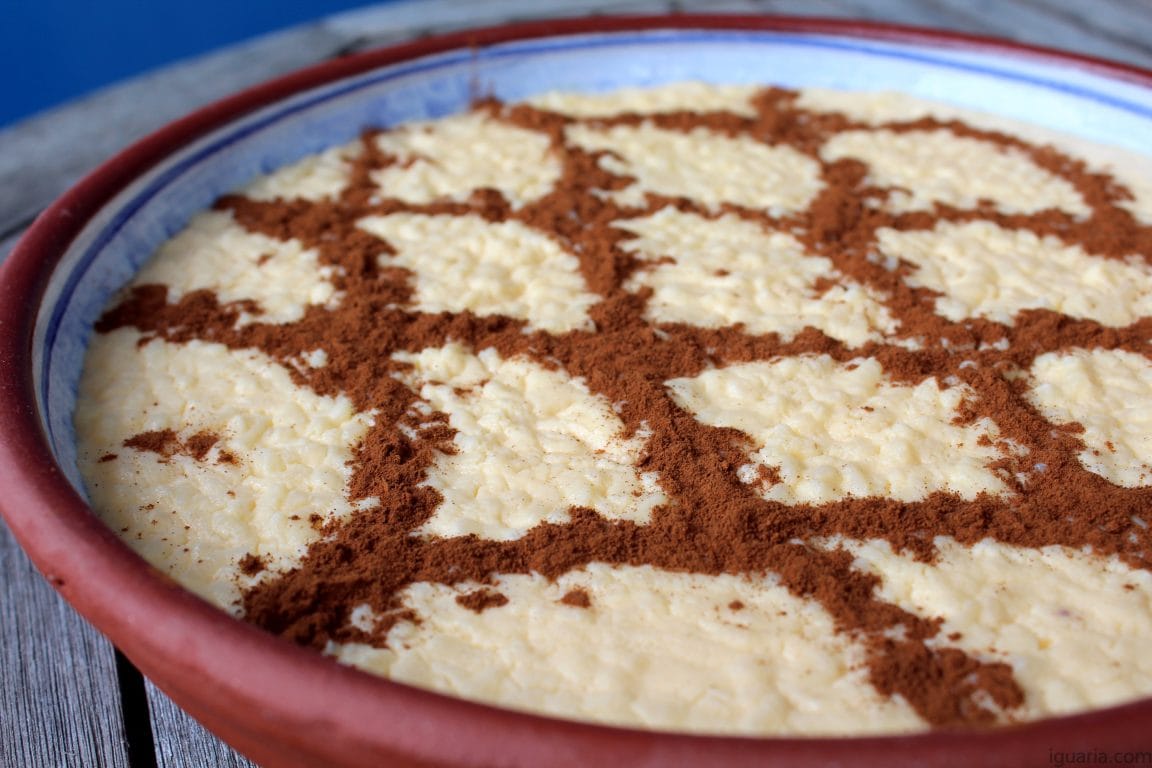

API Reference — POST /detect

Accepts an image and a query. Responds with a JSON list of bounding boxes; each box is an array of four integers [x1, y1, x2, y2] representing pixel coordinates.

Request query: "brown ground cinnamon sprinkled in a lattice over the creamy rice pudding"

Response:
[[98, 89, 1152, 725]]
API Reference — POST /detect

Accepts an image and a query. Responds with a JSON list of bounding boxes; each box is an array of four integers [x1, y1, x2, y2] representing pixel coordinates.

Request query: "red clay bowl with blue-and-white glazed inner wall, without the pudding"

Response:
[[0, 16, 1152, 768]]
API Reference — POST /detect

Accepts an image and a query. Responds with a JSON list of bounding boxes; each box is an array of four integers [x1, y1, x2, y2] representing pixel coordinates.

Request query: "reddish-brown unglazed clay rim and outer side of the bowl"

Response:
[[0, 15, 1152, 766]]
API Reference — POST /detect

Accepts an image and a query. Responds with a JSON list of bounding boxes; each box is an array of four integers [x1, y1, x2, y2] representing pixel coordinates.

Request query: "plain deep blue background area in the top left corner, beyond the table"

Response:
[[0, 0, 400, 128]]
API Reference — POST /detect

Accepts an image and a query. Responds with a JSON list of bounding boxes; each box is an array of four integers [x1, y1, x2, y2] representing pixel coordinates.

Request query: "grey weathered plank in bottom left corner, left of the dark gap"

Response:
[[0, 522, 129, 768]]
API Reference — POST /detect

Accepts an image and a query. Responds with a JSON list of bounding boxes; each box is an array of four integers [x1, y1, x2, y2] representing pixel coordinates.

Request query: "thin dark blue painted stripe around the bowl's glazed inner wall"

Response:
[[39, 29, 1152, 449]]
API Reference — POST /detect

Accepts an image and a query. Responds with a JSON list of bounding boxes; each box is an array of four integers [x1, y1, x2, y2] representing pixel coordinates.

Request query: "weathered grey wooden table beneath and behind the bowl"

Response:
[[0, 0, 1152, 768]]
